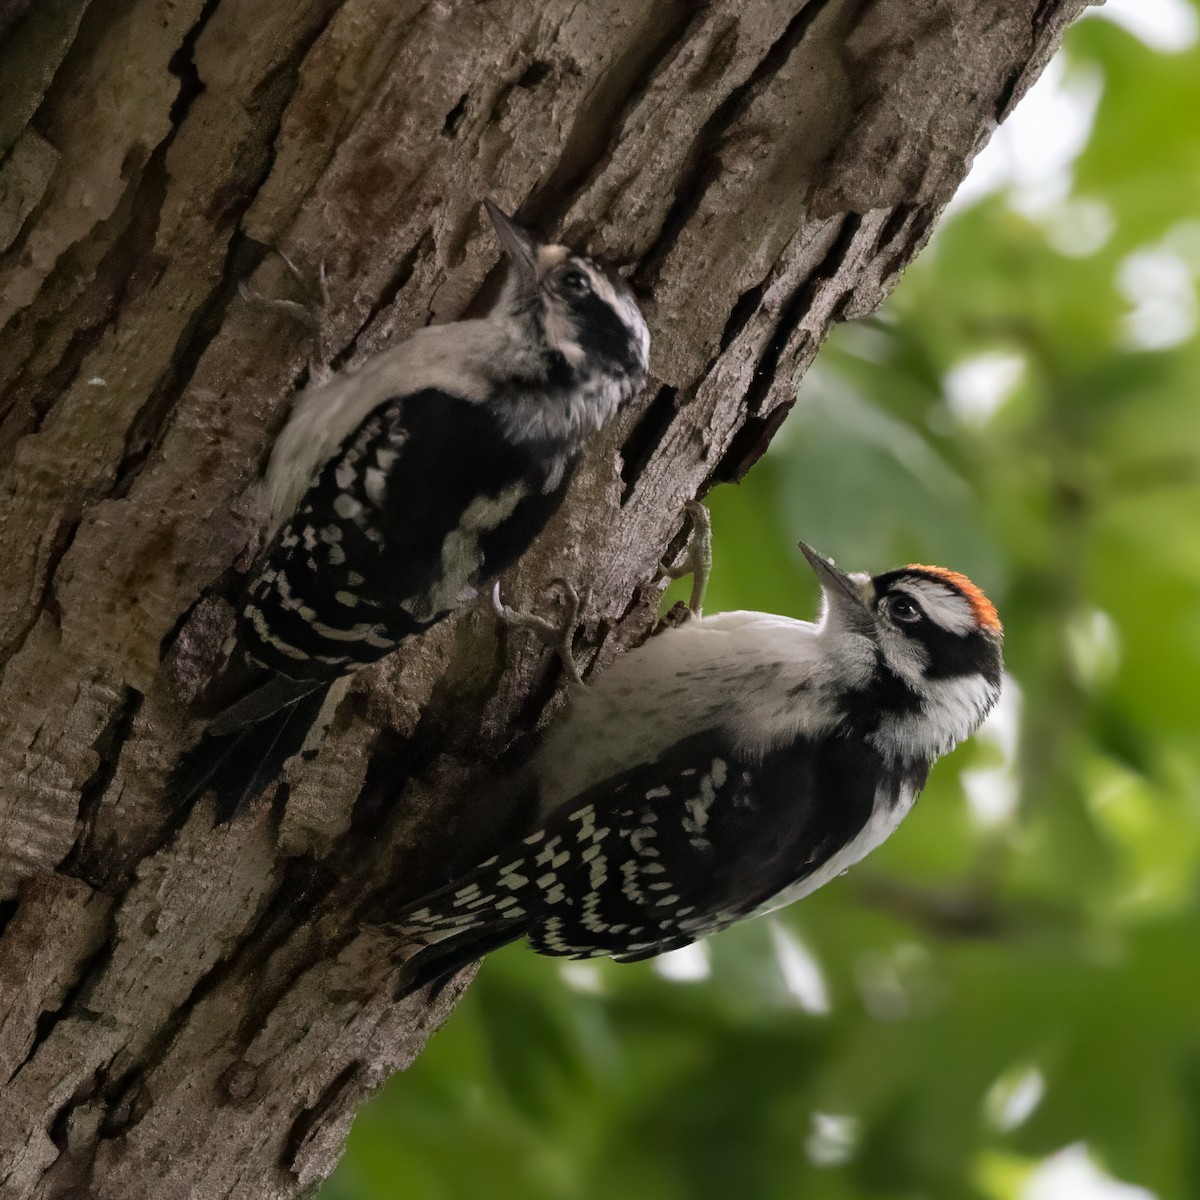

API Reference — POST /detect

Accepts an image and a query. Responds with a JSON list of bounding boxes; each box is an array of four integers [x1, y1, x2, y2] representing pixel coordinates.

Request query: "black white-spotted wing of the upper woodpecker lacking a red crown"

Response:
[[238, 389, 569, 679]]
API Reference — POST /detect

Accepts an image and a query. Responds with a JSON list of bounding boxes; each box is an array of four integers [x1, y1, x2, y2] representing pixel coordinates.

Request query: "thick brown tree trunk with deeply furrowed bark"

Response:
[[0, 0, 1082, 1200]]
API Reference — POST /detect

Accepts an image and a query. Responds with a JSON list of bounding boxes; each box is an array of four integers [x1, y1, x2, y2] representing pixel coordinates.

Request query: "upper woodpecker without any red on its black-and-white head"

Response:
[[175, 200, 649, 818]]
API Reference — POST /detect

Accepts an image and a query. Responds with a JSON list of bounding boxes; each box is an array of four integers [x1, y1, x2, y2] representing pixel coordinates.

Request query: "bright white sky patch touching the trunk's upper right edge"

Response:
[[949, 55, 1104, 216]]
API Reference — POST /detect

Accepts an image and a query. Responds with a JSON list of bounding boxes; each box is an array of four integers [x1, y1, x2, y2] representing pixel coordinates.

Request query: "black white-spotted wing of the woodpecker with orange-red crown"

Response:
[[397, 731, 902, 986]]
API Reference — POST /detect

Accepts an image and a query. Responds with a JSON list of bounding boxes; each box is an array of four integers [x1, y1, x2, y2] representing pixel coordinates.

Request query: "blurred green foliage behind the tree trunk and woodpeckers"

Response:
[[322, 11, 1200, 1200]]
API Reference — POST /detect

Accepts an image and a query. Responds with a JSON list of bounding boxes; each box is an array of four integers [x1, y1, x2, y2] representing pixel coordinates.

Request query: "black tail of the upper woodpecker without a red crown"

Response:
[[167, 685, 329, 824]]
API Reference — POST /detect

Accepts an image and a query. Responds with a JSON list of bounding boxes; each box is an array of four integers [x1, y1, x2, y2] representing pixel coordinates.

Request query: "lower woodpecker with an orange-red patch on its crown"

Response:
[[394, 544, 1002, 995]]
